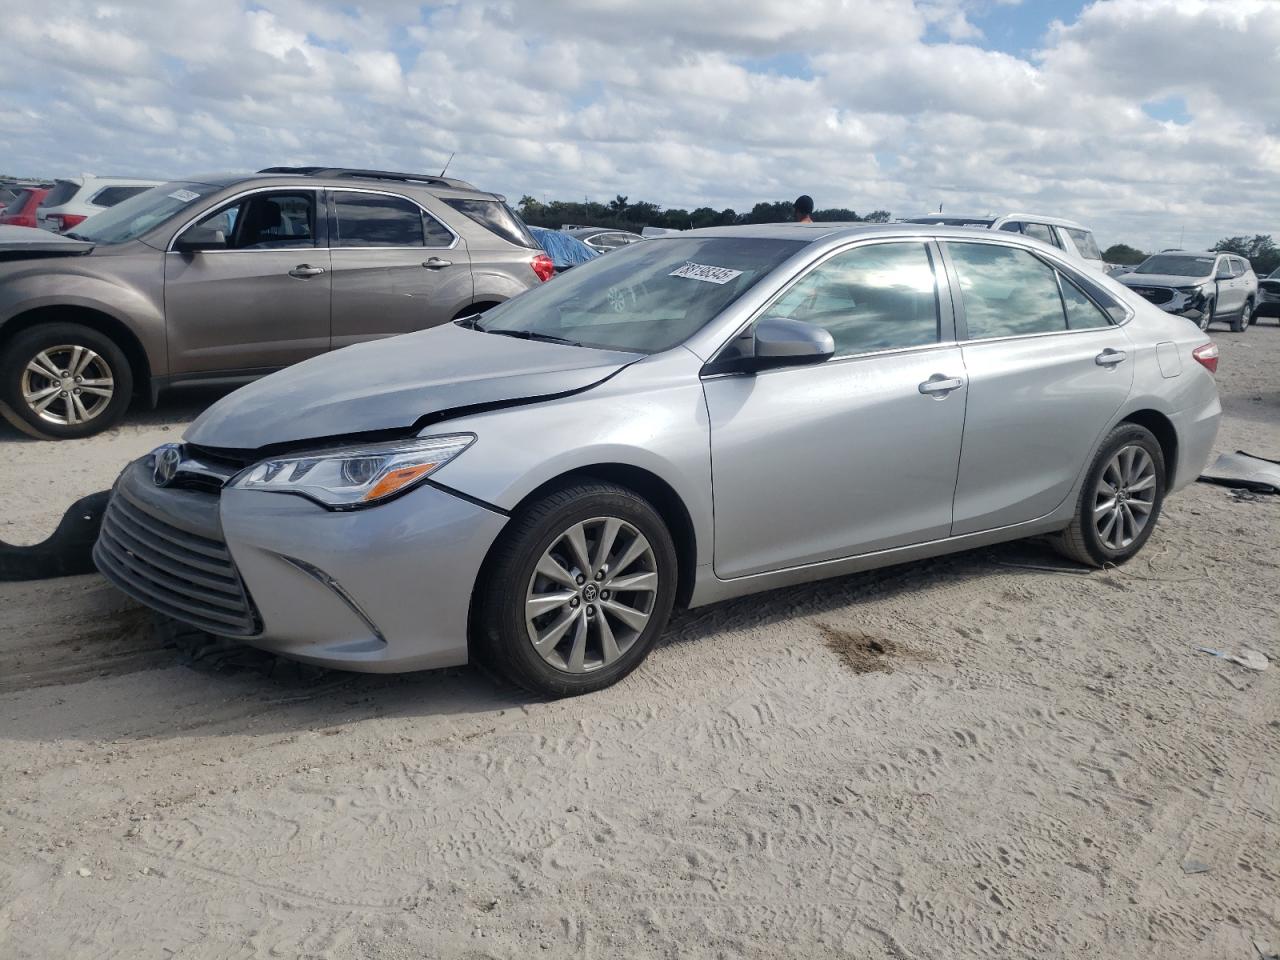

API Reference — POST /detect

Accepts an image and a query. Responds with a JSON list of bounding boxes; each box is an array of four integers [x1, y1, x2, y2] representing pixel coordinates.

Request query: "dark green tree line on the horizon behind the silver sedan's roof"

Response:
[[518, 193, 890, 233]]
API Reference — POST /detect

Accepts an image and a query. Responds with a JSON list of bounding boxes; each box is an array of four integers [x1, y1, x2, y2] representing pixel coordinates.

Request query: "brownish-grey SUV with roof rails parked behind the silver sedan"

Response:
[[0, 166, 553, 439]]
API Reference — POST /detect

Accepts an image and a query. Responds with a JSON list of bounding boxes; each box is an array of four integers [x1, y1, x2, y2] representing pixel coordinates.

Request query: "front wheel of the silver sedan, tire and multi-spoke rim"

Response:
[[472, 479, 678, 698]]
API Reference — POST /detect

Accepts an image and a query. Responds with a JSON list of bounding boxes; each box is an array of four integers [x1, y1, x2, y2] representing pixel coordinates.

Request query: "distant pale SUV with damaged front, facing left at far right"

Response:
[[1115, 250, 1258, 333]]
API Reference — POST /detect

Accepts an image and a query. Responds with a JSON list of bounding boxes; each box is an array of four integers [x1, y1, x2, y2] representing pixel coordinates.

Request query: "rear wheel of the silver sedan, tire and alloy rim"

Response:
[[1055, 424, 1165, 567]]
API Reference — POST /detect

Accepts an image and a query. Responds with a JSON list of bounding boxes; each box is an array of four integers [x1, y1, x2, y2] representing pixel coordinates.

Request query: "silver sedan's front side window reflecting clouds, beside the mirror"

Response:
[[762, 243, 938, 356]]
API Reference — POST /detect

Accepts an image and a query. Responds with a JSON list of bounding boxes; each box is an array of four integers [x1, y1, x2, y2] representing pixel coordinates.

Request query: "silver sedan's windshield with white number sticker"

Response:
[[479, 237, 804, 353]]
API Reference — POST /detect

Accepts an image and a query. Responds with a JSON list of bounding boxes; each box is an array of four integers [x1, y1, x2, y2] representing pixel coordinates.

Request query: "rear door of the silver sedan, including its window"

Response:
[[943, 241, 1134, 536]]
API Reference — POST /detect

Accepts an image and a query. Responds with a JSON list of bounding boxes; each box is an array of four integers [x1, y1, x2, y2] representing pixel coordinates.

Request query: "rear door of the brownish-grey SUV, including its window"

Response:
[[329, 189, 472, 349]]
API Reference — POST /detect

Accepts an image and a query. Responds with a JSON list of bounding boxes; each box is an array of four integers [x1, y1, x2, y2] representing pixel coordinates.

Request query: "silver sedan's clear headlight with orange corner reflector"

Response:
[[233, 434, 476, 509]]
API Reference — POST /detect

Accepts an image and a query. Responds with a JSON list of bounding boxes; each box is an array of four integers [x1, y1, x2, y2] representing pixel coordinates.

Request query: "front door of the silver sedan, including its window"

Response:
[[703, 241, 965, 579]]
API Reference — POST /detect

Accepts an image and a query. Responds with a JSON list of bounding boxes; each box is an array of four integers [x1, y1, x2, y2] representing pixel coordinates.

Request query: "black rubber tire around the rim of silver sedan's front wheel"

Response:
[[472, 479, 678, 698]]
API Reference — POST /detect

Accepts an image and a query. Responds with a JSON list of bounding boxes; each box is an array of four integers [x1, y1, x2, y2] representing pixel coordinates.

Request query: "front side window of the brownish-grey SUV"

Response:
[[177, 191, 316, 250]]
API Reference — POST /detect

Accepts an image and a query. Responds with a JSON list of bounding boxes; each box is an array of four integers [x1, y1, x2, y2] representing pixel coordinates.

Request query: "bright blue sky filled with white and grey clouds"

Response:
[[0, 0, 1280, 248]]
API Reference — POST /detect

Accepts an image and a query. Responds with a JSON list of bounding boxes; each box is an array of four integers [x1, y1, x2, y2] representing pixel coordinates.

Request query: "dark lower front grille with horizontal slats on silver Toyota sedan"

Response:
[[93, 481, 257, 636]]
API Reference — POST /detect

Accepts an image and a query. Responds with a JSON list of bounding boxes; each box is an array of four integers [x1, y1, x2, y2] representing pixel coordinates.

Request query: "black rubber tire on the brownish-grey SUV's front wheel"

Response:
[[0, 323, 133, 440]]
